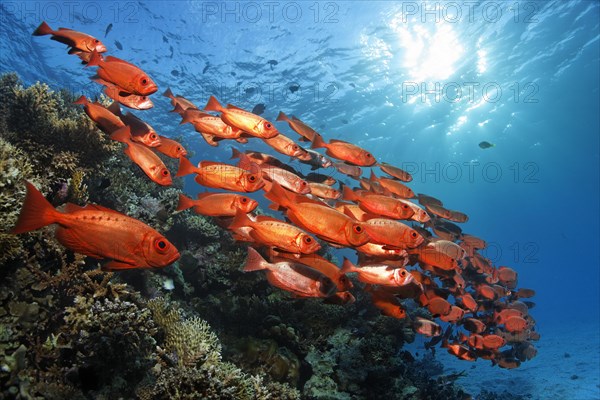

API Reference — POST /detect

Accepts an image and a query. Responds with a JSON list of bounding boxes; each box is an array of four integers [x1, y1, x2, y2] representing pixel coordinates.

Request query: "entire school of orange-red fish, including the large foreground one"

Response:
[[13, 22, 540, 368]]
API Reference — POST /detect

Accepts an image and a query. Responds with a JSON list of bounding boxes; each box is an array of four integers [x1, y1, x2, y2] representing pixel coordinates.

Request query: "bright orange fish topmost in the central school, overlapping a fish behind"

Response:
[[204, 96, 279, 139]]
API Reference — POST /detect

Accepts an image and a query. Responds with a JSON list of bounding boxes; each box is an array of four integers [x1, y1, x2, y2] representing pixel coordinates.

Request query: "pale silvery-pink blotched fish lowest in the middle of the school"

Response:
[[244, 247, 336, 297]]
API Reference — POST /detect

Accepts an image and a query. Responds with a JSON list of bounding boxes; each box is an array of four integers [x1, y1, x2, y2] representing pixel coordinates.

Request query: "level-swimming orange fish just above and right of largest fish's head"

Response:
[[177, 193, 258, 217]]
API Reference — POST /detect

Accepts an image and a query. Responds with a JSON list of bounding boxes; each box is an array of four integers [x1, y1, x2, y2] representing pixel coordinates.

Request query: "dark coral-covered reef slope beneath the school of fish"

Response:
[[0, 74, 516, 400]]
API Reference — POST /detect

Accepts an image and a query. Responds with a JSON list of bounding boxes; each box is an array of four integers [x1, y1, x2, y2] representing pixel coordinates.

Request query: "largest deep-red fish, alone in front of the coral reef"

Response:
[[12, 182, 179, 271]]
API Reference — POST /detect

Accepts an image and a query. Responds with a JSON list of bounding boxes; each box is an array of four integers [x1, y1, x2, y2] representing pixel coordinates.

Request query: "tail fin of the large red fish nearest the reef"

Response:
[[10, 181, 60, 234]]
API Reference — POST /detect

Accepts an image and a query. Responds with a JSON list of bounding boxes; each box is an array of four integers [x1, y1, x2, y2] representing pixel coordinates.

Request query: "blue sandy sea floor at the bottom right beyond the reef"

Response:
[[415, 321, 600, 400]]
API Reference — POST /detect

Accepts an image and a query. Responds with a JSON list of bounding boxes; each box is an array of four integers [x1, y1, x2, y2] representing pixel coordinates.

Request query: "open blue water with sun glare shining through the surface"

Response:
[[0, 1, 600, 396]]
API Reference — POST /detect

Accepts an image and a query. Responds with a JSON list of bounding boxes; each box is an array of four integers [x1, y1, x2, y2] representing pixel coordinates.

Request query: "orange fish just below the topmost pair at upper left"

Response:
[[87, 51, 158, 96]]
